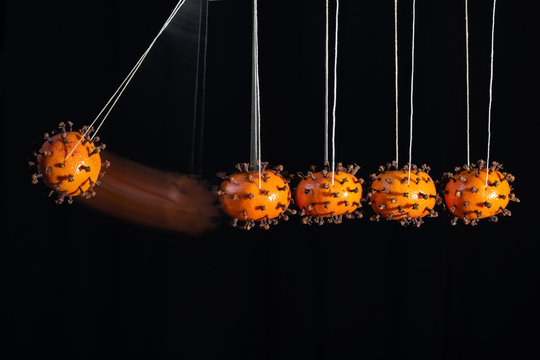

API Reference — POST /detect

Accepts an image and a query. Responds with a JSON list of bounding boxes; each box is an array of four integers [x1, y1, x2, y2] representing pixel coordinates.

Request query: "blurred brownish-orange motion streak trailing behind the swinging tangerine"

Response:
[[81, 152, 220, 235]]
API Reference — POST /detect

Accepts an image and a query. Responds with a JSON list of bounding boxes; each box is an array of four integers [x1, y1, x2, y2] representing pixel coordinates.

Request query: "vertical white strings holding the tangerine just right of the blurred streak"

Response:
[[250, 0, 262, 189]]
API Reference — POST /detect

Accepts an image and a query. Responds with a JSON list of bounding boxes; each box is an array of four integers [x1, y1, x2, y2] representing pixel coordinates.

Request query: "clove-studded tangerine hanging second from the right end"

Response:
[[367, 162, 441, 226]]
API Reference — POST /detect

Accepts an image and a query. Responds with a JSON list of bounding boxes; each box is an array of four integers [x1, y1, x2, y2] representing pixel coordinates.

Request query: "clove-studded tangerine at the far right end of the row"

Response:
[[443, 160, 519, 225]]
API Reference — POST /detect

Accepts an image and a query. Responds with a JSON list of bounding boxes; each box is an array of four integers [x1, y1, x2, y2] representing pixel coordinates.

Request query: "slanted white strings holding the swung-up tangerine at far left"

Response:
[[64, 0, 186, 160]]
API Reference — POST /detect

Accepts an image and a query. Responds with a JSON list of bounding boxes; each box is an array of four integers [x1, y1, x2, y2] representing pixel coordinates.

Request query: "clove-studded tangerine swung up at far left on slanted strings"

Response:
[[29, 122, 109, 204]]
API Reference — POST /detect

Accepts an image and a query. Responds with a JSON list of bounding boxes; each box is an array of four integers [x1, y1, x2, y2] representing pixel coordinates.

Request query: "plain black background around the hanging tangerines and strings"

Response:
[[0, 0, 540, 359]]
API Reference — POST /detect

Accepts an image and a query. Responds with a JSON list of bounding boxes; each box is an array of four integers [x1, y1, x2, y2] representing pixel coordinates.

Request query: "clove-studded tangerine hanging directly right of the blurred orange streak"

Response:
[[217, 163, 295, 230]]
